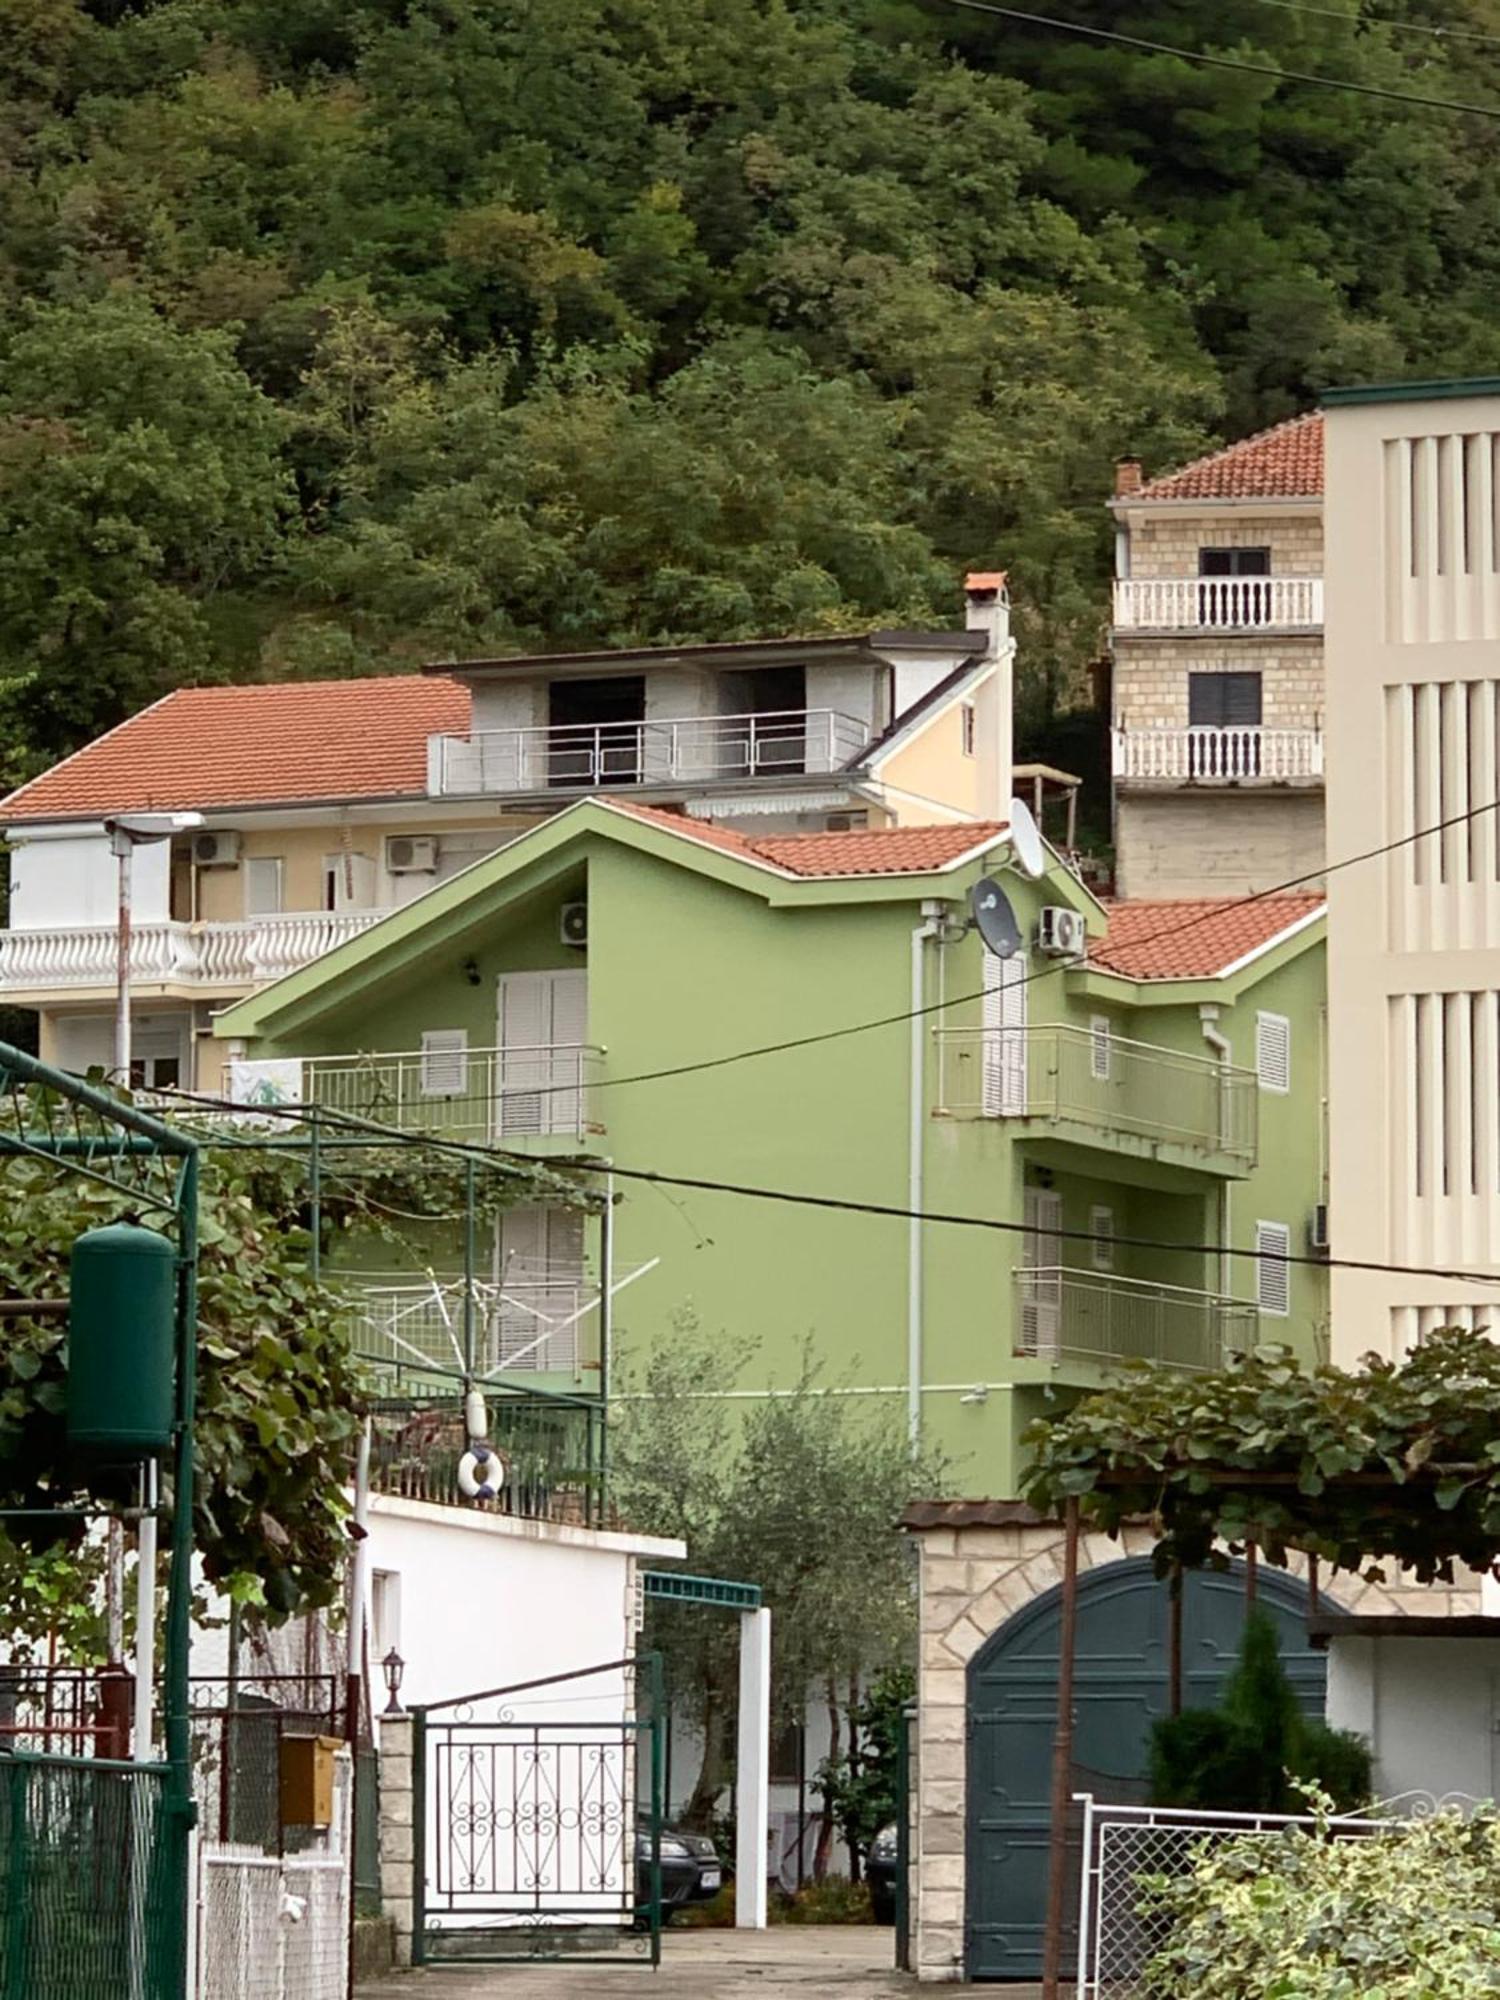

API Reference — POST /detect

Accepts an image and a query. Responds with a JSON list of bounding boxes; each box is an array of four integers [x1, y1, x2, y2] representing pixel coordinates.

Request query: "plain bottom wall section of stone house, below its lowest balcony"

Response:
[[1114, 786, 1324, 898]]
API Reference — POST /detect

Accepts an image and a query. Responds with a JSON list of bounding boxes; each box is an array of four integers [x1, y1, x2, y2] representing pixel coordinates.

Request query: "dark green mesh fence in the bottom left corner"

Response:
[[0, 1752, 182, 2000]]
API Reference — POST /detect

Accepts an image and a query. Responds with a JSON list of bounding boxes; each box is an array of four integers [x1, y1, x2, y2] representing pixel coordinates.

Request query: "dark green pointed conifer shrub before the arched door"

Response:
[[1150, 1612, 1370, 1812]]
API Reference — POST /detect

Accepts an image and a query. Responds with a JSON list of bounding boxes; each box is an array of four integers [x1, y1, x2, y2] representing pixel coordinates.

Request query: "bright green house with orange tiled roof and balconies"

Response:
[[216, 798, 1326, 1494]]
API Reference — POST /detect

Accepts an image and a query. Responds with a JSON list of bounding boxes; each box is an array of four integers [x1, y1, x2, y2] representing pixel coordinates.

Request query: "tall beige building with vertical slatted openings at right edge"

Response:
[[1326, 380, 1500, 1362]]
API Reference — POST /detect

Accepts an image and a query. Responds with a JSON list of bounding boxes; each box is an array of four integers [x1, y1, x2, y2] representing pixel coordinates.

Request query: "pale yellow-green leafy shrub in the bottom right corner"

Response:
[[1138, 1798, 1500, 2000]]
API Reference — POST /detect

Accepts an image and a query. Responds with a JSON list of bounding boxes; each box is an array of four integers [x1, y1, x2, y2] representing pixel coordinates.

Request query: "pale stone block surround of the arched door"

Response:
[[912, 1502, 1480, 1982]]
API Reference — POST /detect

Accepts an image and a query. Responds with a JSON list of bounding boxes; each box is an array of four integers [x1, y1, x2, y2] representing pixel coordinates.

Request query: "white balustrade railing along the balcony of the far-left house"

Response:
[[0, 910, 390, 992]]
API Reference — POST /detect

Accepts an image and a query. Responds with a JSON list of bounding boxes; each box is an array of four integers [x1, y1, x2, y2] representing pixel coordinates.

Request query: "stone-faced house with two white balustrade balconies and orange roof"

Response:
[[1110, 412, 1324, 898]]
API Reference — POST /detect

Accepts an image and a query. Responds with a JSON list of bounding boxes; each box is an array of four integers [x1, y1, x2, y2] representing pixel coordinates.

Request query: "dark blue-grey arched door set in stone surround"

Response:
[[966, 1562, 1324, 1980]]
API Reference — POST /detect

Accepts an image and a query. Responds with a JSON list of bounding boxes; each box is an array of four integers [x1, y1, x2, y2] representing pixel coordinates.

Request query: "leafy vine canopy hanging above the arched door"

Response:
[[1022, 1328, 1500, 1584]]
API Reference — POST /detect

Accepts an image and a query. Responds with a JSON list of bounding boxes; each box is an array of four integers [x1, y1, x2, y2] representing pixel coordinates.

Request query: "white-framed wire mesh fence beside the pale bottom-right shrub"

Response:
[[1074, 1794, 1402, 2000]]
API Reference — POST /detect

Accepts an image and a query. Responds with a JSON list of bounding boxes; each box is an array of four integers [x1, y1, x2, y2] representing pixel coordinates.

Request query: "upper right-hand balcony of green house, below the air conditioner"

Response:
[[934, 1026, 1260, 1176]]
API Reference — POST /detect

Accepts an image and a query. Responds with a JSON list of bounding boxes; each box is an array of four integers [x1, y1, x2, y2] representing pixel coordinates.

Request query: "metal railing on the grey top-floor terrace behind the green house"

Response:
[[436, 708, 870, 796]]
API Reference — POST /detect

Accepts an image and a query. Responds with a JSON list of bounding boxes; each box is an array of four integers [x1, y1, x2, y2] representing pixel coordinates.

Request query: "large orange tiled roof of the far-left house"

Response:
[[0, 674, 470, 822]]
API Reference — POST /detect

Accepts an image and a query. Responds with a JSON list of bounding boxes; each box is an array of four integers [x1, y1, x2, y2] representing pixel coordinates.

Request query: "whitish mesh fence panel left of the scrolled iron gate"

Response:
[[196, 1752, 354, 2000]]
